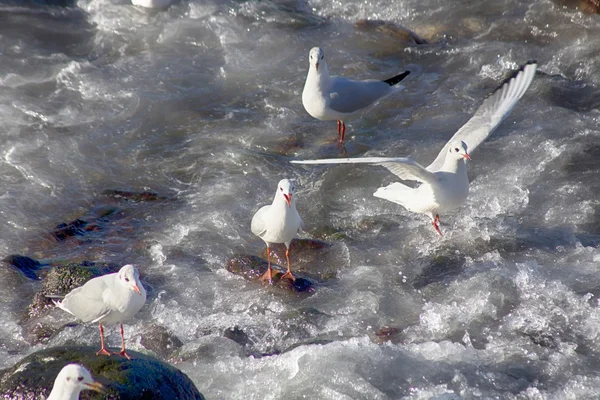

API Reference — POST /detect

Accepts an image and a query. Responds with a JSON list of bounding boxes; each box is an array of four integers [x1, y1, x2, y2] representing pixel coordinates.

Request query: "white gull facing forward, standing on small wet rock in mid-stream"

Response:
[[250, 179, 304, 284]]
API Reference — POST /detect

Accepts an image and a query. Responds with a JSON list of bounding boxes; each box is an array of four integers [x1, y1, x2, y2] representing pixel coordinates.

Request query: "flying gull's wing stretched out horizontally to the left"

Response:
[[290, 157, 437, 184]]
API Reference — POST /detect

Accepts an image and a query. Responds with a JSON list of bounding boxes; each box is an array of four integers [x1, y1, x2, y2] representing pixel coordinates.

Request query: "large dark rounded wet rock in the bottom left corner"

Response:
[[0, 347, 204, 400]]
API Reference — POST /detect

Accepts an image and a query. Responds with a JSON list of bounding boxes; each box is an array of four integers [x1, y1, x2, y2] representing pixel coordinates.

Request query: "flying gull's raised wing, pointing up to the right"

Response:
[[427, 61, 537, 171]]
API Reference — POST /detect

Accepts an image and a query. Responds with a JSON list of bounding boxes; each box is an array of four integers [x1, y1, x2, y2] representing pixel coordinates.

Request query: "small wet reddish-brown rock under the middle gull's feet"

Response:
[[225, 254, 314, 293]]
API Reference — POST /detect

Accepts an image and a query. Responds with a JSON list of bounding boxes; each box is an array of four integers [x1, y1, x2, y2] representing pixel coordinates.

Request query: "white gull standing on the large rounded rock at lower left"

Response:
[[54, 264, 146, 359]]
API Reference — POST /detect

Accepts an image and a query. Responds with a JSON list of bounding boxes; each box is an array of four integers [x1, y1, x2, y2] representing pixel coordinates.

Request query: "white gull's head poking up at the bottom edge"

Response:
[[48, 364, 105, 400]]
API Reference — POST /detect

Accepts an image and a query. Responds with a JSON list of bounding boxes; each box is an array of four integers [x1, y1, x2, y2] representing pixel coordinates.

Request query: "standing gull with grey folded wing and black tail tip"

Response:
[[302, 47, 410, 144]]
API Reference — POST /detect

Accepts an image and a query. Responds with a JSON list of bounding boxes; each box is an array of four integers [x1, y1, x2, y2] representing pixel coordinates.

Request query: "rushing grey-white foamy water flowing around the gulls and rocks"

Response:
[[0, 0, 600, 400]]
